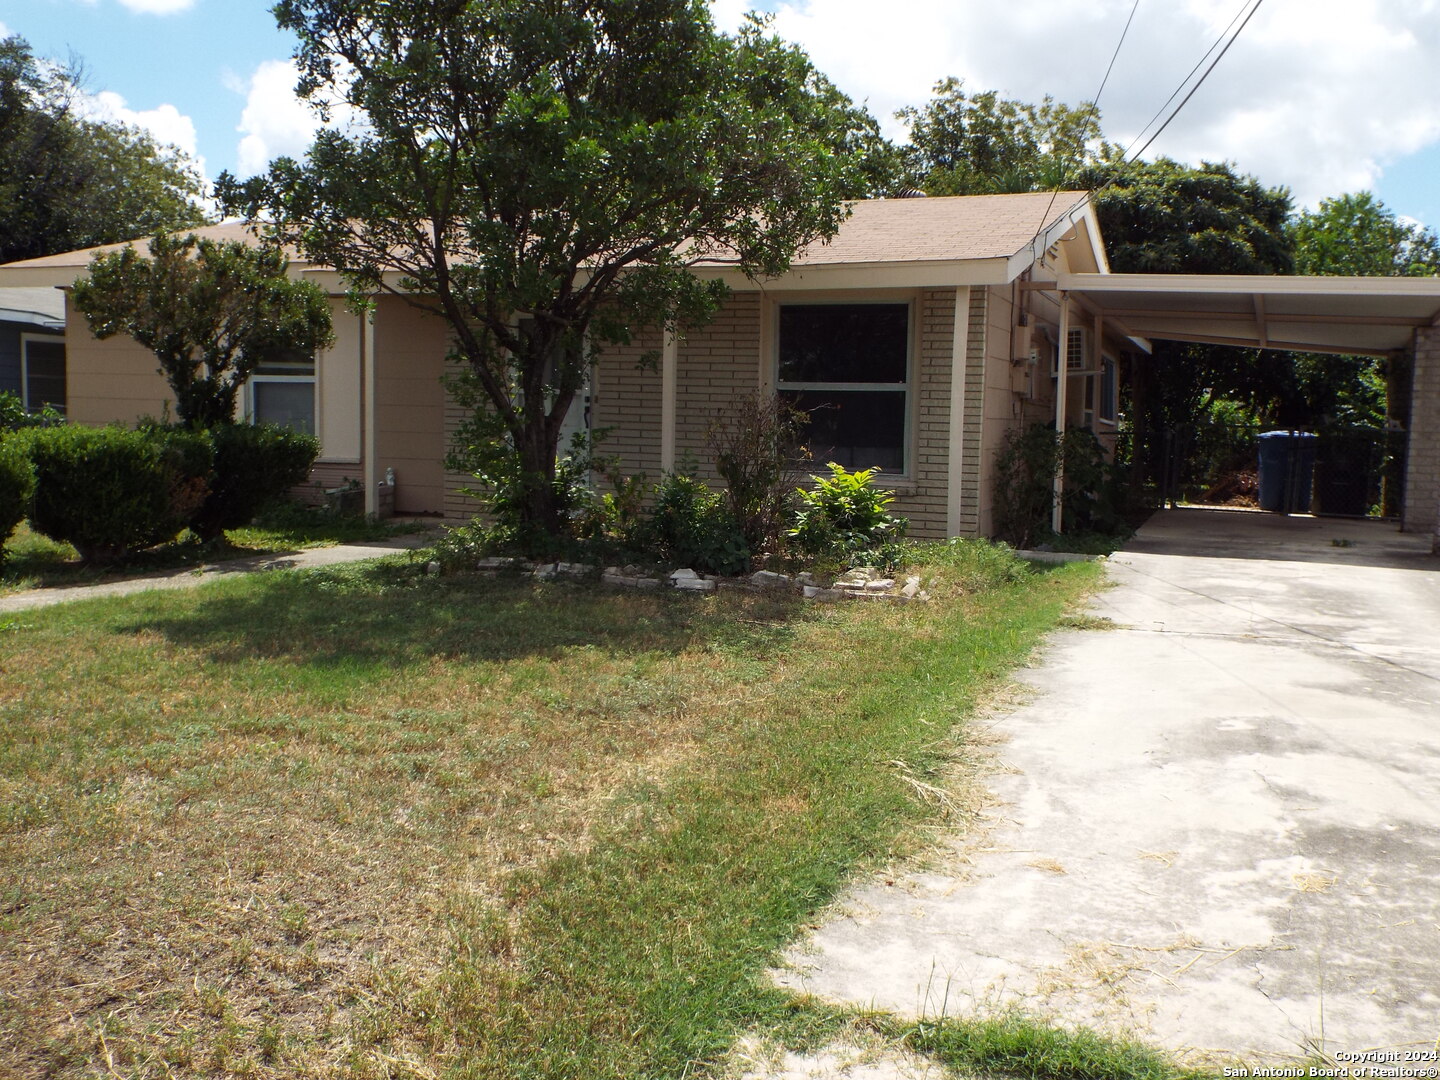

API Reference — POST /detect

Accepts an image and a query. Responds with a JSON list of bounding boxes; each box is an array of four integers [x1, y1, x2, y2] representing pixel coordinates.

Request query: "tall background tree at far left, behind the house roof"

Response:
[[0, 36, 204, 262]]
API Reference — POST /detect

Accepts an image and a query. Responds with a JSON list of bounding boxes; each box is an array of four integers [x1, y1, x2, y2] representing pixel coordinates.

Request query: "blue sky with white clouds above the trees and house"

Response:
[[0, 0, 1440, 228]]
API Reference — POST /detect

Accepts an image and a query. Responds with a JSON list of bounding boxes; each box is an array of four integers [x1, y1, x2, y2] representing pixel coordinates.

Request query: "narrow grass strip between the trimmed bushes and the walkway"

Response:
[[0, 505, 419, 595]]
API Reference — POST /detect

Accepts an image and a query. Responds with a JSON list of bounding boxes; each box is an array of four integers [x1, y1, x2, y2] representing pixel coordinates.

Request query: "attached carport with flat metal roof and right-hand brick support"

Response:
[[1056, 274, 1440, 544]]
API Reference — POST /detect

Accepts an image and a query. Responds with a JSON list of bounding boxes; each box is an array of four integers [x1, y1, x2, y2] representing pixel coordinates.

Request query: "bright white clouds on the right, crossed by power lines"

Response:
[[714, 0, 1440, 204]]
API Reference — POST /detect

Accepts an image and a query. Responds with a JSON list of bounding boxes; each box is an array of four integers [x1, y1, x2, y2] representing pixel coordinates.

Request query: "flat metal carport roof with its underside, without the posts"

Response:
[[1056, 274, 1440, 356]]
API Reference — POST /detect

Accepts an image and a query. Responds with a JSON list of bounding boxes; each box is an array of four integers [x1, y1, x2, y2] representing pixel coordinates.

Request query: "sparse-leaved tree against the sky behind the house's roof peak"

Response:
[[896, 78, 1117, 194]]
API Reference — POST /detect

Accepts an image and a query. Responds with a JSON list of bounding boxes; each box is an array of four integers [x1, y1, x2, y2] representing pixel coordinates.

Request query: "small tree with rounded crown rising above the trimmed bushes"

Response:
[[72, 235, 334, 428]]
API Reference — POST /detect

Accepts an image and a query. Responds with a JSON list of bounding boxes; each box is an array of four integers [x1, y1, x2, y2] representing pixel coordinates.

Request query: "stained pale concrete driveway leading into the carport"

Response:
[[779, 510, 1440, 1076]]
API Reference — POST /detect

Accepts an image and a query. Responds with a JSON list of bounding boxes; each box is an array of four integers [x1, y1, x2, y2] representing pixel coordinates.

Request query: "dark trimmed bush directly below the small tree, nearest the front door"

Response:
[[190, 423, 320, 540]]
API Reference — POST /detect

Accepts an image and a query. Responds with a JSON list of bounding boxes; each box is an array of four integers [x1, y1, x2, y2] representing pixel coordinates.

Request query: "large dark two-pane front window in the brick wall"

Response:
[[776, 304, 910, 474]]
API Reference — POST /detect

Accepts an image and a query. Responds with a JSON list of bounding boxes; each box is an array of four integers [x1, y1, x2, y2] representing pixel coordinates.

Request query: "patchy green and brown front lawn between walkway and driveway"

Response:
[[0, 543, 1215, 1080]]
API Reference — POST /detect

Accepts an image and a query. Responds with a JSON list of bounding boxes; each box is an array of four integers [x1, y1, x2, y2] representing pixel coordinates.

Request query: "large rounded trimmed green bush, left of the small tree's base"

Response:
[[12, 426, 213, 563]]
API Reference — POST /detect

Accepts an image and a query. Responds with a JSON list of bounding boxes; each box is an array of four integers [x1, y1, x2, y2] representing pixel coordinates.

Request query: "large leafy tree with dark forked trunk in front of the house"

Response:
[[219, 0, 884, 536]]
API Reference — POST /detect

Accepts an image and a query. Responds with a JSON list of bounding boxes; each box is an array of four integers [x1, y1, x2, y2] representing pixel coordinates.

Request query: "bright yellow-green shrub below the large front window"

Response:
[[789, 461, 910, 569]]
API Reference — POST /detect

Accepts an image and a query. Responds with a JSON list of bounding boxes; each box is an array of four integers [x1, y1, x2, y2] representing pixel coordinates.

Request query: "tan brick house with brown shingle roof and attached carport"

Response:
[[0, 192, 1440, 537]]
